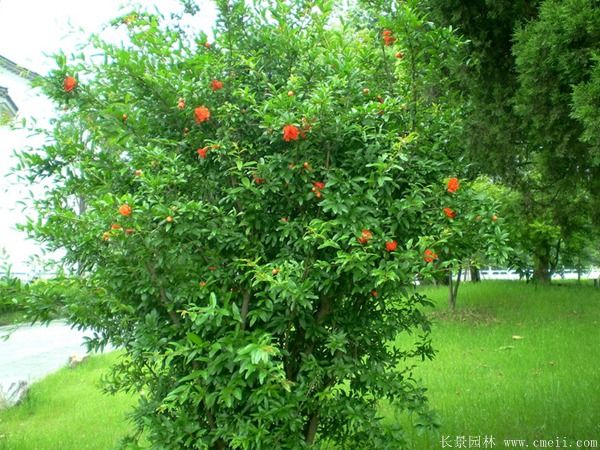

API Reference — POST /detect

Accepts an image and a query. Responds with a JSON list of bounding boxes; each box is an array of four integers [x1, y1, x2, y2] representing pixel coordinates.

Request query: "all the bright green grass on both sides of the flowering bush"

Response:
[[0, 282, 600, 450]]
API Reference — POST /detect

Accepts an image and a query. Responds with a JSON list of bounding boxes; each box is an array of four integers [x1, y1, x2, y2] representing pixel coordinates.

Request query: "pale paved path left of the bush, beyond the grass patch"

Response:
[[0, 320, 92, 398]]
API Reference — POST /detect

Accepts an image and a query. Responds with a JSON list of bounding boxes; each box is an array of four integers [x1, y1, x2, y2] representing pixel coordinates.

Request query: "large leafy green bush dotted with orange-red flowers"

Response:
[[18, 1, 498, 449]]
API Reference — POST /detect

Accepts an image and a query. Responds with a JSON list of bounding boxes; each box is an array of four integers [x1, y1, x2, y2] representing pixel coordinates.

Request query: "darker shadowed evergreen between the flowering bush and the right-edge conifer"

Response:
[[422, 0, 540, 182]]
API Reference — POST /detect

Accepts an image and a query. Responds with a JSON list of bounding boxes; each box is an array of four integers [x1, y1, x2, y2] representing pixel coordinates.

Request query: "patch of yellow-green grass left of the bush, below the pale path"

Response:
[[0, 353, 135, 450]]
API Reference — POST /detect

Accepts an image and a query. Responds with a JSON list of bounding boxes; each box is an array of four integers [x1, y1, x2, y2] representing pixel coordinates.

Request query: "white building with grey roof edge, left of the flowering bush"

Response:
[[0, 55, 52, 278]]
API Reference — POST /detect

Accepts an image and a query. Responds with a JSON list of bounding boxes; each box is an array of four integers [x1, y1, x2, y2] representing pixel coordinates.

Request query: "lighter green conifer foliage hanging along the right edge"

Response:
[[513, 0, 600, 278]]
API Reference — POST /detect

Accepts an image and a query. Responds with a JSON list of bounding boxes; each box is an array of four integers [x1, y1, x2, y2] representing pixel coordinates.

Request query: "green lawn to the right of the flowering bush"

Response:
[[388, 282, 600, 449]]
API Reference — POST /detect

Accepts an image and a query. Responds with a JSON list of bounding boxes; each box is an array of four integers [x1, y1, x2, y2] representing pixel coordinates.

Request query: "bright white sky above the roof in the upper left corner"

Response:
[[0, 0, 214, 74]]
